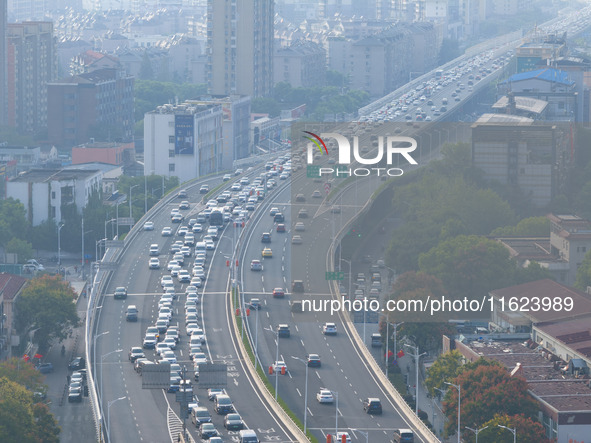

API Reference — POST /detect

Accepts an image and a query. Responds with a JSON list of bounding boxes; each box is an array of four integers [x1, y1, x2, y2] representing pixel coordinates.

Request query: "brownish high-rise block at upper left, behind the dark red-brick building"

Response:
[[6, 22, 57, 134]]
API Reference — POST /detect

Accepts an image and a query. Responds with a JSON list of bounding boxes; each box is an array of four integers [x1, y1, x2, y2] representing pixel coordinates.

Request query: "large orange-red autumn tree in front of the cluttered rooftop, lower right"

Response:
[[443, 362, 538, 441]]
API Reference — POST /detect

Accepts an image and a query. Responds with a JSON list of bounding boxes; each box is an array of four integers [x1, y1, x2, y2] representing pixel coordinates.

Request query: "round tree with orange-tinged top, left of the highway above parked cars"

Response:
[[16, 275, 79, 352]]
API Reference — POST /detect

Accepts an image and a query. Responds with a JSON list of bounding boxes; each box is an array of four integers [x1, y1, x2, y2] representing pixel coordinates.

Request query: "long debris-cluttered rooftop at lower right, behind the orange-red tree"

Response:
[[464, 340, 591, 412]]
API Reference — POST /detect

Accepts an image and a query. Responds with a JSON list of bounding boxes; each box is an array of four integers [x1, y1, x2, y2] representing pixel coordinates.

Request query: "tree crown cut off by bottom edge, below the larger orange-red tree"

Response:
[[476, 414, 550, 443]]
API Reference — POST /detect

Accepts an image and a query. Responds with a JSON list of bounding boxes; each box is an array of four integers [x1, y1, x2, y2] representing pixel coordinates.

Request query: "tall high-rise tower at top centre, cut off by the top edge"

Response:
[[207, 0, 274, 97]]
